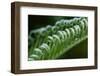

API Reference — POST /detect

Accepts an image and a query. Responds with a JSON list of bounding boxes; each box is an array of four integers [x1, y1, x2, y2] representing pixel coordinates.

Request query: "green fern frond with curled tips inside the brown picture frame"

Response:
[[28, 17, 88, 60]]
